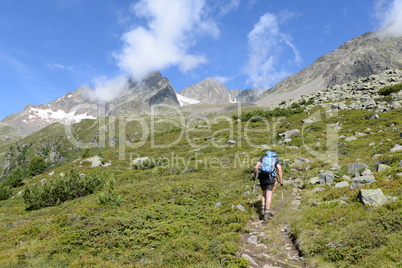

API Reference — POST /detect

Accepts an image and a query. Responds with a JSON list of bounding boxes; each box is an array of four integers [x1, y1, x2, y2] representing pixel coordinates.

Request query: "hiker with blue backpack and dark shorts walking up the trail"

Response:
[[254, 150, 283, 220]]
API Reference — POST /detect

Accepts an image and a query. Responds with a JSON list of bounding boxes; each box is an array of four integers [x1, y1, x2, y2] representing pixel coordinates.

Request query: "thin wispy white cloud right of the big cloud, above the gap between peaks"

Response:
[[245, 12, 301, 88]]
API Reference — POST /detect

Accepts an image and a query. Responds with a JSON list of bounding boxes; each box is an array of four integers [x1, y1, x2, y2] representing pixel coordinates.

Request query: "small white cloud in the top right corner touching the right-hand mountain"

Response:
[[375, 0, 402, 36]]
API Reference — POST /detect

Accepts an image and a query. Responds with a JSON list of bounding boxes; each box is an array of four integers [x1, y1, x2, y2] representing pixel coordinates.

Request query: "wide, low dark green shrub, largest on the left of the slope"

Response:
[[23, 169, 104, 209]]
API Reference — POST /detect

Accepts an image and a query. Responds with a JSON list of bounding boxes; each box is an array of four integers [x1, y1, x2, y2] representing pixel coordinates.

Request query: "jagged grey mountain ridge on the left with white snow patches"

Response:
[[0, 72, 180, 141]]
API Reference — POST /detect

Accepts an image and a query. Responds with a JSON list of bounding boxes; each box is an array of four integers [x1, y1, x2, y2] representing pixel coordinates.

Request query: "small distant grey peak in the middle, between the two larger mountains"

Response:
[[179, 77, 232, 104]]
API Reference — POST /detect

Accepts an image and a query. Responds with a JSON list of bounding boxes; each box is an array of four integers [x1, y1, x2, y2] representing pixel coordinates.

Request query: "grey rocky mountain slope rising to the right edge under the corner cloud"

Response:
[[257, 32, 402, 105]]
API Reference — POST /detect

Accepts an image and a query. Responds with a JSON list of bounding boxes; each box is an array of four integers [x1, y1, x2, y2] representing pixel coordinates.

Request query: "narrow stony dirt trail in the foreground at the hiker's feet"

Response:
[[240, 182, 311, 268]]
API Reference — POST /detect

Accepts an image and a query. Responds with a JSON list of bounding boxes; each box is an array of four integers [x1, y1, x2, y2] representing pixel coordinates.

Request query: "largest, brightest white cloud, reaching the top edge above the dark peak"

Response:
[[114, 0, 219, 81]]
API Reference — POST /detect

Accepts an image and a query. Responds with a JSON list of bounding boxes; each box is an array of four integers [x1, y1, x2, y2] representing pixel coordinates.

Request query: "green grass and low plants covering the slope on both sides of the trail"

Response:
[[0, 100, 402, 267]]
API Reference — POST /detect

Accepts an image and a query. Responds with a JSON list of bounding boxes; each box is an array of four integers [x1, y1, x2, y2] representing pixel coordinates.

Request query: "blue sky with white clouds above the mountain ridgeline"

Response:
[[0, 0, 402, 119]]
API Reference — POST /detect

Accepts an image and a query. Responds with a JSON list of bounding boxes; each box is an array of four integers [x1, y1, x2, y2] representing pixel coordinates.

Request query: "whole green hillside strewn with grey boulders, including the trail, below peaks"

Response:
[[0, 70, 402, 267]]
